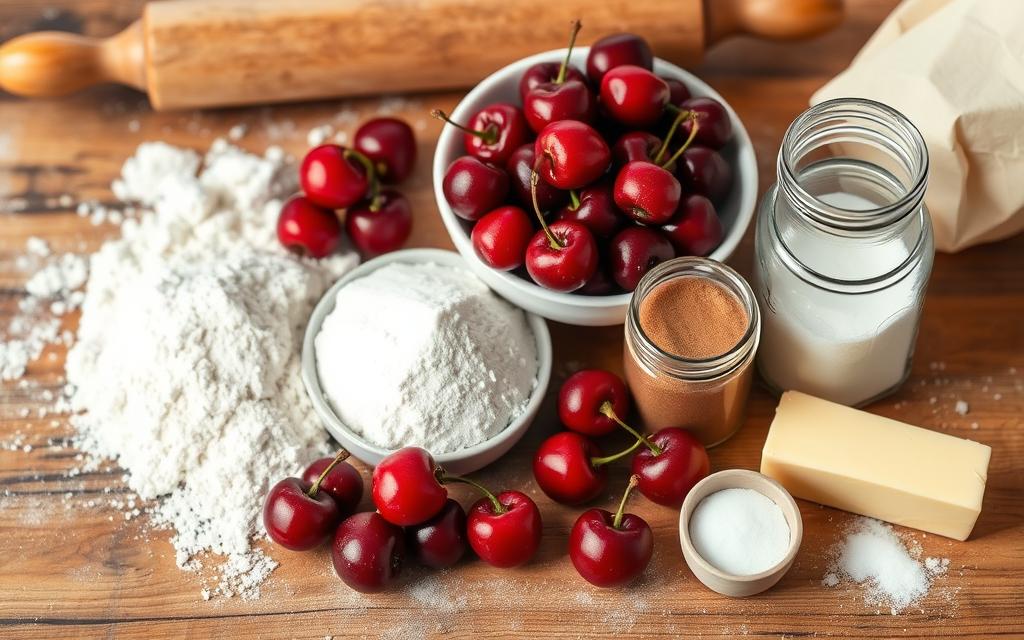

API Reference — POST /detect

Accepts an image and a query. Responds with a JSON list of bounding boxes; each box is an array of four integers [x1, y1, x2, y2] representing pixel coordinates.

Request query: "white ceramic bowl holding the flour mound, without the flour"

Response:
[[302, 249, 551, 474]]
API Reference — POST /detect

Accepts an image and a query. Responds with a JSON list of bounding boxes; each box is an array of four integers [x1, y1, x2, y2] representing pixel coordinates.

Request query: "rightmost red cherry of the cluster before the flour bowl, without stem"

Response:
[[467, 492, 543, 568]]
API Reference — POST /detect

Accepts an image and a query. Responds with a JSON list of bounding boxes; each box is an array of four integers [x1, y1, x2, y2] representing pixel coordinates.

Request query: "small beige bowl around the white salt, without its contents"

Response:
[[679, 469, 804, 598]]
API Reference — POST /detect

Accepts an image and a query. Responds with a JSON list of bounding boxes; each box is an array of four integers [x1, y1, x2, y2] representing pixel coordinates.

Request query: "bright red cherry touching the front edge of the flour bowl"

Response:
[[372, 446, 447, 526]]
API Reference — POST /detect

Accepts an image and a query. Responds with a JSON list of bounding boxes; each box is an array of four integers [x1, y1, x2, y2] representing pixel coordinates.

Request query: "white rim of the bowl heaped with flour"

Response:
[[300, 249, 554, 464]]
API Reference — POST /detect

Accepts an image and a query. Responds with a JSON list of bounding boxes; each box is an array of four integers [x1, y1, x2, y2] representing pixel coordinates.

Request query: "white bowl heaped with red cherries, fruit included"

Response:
[[433, 23, 757, 326]]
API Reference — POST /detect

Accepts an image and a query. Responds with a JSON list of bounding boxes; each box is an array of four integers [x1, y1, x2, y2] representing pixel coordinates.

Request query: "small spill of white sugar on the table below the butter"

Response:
[[821, 517, 949, 614]]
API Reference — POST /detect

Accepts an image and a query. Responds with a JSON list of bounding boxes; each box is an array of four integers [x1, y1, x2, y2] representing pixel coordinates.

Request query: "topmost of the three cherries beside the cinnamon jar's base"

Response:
[[558, 369, 630, 437]]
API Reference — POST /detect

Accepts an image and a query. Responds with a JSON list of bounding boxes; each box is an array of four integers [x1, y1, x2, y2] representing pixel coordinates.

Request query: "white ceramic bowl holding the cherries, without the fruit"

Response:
[[433, 47, 758, 326]]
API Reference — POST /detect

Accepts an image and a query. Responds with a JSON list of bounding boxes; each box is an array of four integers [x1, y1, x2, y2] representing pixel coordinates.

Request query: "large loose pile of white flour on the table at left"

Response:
[[67, 140, 356, 597]]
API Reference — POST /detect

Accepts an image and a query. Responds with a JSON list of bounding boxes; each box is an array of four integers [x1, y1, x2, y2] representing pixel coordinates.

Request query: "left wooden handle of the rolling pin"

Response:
[[0, 23, 145, 97]]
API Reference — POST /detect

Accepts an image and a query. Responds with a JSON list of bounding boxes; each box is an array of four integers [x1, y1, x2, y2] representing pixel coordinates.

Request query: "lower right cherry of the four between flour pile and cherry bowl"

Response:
[[345, 189, 413, 257]]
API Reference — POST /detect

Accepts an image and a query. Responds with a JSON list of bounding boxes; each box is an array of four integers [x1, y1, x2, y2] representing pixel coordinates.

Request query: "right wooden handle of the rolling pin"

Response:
[[703, 0, 843, 44]]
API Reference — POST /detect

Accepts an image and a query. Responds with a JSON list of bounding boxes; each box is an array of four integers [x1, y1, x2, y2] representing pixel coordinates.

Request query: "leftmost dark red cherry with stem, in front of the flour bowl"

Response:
[[263, 450, 348, 551]]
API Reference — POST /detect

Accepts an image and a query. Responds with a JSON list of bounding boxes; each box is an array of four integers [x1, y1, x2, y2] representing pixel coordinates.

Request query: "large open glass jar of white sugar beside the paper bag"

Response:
[[754, 98, 935, 406]]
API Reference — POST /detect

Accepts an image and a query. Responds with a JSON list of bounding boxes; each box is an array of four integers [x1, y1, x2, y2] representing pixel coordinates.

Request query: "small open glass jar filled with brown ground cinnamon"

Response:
[[624, 257, 761, 446]]
